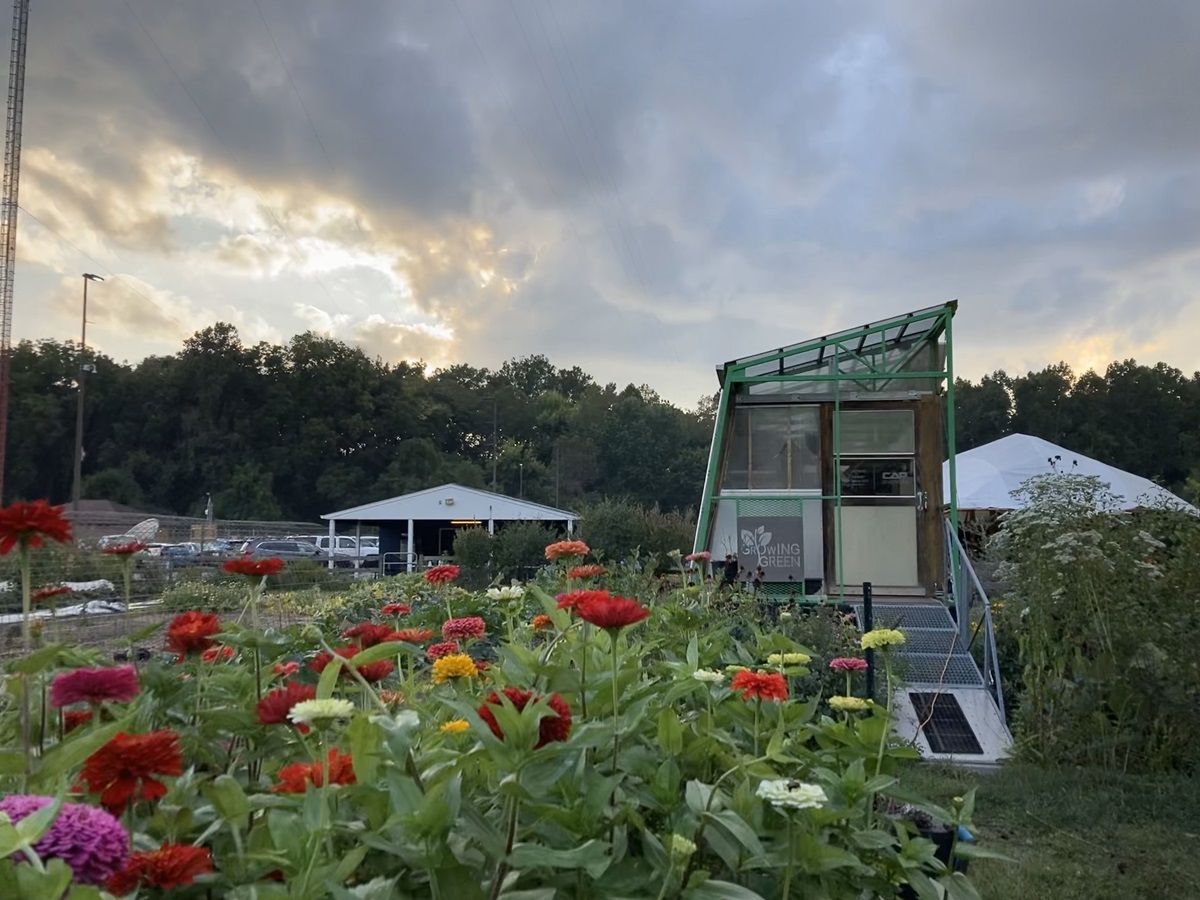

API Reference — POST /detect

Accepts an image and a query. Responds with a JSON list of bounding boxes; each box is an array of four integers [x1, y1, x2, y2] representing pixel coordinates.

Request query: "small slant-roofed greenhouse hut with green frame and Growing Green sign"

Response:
[[696, 302, 956, 600]]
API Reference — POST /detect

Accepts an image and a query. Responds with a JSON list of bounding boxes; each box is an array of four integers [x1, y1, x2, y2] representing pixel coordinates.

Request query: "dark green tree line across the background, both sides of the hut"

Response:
[[6, 324, 1200, 521]]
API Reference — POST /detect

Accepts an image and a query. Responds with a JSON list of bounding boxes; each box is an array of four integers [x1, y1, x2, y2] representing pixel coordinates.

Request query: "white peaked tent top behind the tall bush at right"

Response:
[[942, 434, 1200, 512]]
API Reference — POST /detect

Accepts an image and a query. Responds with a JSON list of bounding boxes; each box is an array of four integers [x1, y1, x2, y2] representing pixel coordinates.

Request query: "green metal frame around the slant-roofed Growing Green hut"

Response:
[[694, 300, 960, 607]]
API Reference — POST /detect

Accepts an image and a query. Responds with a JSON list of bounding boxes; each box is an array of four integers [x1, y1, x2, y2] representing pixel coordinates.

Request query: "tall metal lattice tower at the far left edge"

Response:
[[0, 0, 29, 502]]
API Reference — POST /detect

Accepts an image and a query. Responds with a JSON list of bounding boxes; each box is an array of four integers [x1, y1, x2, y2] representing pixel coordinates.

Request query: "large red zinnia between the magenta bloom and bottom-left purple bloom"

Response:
[[79, 731, 184, 815]]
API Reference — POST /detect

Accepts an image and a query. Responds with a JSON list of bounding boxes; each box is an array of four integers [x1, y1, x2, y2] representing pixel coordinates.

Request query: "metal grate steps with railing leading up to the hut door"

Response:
[[851, 520, 1013, 766]]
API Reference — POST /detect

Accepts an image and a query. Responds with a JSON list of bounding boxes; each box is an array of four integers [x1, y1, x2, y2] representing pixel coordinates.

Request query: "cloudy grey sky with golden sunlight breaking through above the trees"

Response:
[[5, 0, 1200, 406]]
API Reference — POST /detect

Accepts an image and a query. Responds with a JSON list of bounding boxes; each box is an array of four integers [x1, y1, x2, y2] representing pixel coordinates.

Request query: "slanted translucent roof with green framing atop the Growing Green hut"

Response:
[[716, 300, 958, 386]]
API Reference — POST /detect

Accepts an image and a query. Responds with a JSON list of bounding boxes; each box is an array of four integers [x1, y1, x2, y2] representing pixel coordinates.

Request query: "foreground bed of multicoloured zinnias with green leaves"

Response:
[[0, 504, 984, 900]]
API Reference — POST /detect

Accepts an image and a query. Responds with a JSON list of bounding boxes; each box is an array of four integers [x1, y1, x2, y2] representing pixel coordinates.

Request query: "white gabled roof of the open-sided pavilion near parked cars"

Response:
[[322, 485, 578, 522]]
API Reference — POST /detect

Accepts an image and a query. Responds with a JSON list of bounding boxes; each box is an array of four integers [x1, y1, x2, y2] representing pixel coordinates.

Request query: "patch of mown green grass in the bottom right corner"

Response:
[[905, 766, 1200, 900]]
